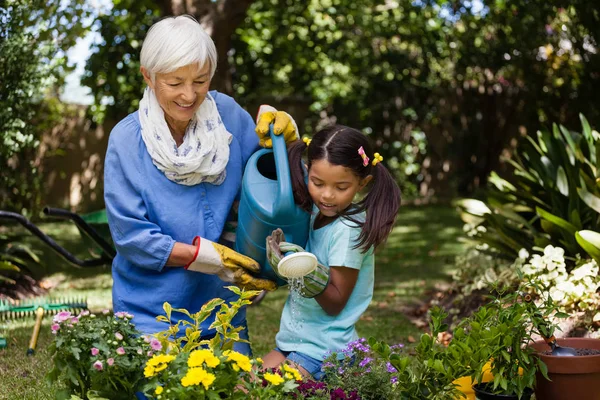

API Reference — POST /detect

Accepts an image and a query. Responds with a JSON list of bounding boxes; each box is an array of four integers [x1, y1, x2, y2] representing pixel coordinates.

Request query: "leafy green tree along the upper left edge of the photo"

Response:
[[0, 0, 89, 211]]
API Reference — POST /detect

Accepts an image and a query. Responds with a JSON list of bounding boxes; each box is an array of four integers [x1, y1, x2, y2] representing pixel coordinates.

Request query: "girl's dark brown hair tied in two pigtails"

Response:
[[289, 125, 401, 251]]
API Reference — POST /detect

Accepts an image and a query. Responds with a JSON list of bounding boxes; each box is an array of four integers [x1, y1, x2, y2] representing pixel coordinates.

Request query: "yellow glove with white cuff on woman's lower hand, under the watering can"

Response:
[[185, 236, 277, 291]]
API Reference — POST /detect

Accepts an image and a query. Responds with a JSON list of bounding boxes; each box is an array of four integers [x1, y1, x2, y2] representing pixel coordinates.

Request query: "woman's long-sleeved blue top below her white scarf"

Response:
[[104, 91, 258, 336]]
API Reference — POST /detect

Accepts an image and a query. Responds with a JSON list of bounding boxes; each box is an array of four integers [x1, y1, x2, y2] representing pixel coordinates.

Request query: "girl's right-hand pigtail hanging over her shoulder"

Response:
[[356, 162, 401, 250]]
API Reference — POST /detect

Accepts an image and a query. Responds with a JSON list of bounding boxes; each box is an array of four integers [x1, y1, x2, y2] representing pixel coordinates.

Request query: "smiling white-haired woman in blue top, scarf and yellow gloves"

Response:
[[104, 16, 297, 354]]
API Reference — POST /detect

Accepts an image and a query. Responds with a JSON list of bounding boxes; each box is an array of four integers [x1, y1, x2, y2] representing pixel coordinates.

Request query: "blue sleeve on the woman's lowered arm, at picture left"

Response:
[[104, 126, 175, 271]]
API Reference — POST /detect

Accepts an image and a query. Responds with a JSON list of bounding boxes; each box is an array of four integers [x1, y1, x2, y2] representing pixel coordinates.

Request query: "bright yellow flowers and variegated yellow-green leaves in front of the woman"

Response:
[[143, 286, 301, 400]]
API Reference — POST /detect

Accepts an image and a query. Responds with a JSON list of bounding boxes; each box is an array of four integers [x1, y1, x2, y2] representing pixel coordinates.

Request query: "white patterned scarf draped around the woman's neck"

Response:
[[139, 87, 232, 186]]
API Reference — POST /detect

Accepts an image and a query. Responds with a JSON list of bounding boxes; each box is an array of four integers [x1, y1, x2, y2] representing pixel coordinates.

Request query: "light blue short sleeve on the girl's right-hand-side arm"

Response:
[[329, 222, 366, 269]]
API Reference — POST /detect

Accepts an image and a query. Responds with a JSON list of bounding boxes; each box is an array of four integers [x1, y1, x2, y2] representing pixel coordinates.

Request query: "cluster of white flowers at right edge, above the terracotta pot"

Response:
[[521, 245, 600, 320]]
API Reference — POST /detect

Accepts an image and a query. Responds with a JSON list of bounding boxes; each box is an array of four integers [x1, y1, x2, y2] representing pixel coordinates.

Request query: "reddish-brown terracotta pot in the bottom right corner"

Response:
[[531, 338, 600, 400]]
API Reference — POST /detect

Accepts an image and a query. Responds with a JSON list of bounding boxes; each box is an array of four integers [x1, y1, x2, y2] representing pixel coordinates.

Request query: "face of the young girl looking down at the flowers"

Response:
[[308, 160, 372, 217]]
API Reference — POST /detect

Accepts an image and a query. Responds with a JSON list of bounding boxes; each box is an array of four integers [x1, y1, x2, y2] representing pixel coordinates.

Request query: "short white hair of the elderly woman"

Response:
[[140, 15, 217, 81]]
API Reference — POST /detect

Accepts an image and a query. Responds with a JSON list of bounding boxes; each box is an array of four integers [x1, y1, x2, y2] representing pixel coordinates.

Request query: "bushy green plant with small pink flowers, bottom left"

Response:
[[47, 310, 152, 400]]
